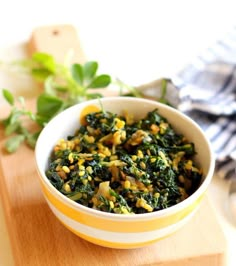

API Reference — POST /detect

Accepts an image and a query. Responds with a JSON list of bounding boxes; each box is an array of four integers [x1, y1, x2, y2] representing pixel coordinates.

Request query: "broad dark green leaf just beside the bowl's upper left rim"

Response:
[[37, 93, 63, 118]]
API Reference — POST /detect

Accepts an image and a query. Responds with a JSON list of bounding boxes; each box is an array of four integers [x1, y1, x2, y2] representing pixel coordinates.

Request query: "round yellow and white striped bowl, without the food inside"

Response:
[[35, 97, 215, 248]]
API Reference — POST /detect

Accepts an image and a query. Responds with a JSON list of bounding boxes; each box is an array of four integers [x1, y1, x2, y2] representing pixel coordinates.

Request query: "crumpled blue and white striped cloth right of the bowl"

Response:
[[172, 27, 236, 179]]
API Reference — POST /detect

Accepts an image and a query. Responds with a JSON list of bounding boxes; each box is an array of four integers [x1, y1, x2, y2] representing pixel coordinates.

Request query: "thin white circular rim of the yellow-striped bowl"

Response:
[[34, 96, 215, 221]]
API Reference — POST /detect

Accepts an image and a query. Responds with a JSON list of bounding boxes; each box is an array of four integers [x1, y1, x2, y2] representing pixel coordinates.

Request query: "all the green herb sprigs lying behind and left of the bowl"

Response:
[[0, 52, 168, 153]]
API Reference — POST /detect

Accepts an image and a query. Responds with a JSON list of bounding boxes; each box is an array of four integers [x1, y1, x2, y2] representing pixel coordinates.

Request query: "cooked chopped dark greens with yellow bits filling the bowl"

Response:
[[46, 109, 202, 214]]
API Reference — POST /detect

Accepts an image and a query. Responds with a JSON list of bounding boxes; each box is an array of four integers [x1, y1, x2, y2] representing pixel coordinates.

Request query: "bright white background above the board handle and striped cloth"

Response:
[[0, 0, 236, 85]]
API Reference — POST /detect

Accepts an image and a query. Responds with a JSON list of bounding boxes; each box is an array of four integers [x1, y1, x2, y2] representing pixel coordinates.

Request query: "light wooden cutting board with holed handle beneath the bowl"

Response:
[[0, 26, 226, 266]]
